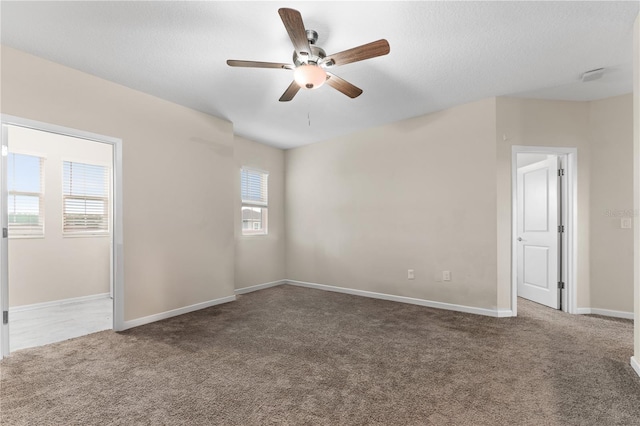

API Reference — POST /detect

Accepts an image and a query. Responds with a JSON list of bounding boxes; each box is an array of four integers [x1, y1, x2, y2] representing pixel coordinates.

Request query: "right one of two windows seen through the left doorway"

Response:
[[62, 161, 109, 234]]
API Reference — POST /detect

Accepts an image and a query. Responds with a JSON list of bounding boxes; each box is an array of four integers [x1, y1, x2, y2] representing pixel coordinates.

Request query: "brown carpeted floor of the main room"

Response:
[[0, 286, 640, 426]]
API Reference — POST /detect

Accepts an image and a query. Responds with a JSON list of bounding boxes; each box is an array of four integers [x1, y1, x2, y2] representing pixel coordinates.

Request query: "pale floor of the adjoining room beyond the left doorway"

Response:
[[9, 297, 113, 352]]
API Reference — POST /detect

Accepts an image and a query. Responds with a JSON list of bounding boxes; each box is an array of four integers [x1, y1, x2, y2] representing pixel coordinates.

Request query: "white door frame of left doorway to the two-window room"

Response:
[[0, 114, 125, 359]]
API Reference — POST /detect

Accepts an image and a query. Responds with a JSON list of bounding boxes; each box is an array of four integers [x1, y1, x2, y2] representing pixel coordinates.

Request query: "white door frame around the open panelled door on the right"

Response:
[[511, 145, 578, 316]]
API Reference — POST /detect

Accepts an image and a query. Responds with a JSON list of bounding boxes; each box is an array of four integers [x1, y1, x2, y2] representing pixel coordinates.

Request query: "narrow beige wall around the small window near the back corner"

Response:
[[234, 136, 286, 289]]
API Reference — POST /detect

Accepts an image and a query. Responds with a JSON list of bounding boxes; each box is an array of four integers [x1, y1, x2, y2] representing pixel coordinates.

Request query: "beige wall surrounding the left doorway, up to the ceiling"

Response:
[[1, 46, 236, 320]]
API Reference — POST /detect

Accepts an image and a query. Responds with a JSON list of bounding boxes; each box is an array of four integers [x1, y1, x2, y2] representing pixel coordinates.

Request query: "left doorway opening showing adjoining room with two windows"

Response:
[[0, 115, 124, 358]]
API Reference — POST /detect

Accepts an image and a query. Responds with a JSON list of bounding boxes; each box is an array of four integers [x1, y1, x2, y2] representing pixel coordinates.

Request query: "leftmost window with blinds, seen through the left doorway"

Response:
[[7, 153, 44, 237]]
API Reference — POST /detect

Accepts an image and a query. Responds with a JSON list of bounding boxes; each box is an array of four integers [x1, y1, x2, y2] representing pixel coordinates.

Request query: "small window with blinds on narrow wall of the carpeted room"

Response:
[[240, 169, 269, 235]]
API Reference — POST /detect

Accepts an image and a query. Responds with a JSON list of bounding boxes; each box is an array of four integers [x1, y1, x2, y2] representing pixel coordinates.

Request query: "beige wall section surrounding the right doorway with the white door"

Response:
[[496, 98, 591, 307]]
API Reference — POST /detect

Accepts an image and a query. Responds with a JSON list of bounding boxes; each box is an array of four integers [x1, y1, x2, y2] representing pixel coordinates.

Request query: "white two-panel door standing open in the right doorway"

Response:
[[515, 156, 560, 309]]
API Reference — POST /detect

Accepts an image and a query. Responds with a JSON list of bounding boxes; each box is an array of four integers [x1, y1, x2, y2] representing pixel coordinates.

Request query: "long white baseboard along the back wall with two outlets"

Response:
[[285, 280, 512, 317]]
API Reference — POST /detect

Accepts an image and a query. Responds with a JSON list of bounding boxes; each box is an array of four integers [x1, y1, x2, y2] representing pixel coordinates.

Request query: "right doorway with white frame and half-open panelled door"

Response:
[[511, 146, 577, 315]]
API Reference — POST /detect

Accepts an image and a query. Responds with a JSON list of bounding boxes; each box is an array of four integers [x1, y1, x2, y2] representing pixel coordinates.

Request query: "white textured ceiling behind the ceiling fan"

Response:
[[0, 0, 639, 148]]
